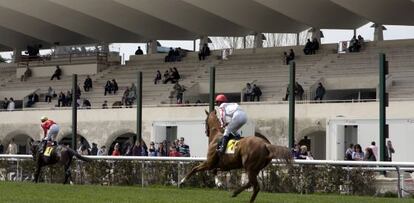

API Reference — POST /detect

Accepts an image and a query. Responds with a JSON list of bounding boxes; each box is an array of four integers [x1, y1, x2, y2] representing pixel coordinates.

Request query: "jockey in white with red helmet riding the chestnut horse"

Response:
[[216, 94, 247, 154]]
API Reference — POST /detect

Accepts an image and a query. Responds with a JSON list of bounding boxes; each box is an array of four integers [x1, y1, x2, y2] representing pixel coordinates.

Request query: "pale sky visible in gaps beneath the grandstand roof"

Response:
[[0, 23, 414, 60]]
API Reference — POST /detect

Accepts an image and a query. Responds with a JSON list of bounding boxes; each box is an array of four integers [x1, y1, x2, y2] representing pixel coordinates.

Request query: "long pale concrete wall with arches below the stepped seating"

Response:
[[0, 101, 414, 158]]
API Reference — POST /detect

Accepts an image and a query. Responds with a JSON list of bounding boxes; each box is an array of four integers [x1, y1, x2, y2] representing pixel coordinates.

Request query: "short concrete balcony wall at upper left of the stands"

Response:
[[16, 64, 101, 78]]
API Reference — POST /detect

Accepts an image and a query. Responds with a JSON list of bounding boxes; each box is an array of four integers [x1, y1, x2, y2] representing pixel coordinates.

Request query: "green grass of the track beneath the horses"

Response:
[[0, 182, 414, 203]]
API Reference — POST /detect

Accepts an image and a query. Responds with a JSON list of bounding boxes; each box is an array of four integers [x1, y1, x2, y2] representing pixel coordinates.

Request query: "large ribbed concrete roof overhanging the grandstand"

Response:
[[0, 0, 414, 50]]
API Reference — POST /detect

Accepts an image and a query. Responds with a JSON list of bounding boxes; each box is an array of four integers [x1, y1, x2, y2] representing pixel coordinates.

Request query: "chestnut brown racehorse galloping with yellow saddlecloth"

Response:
[[180, 111, 292, 202]]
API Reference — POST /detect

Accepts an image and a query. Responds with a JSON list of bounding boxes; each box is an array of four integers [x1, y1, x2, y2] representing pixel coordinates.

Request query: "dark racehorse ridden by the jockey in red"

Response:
[[30, 141, 91, 184]]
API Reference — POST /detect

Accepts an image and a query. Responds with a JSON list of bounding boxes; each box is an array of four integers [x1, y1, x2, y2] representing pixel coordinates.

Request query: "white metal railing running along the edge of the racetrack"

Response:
[[0, 154, 414, 198]]
